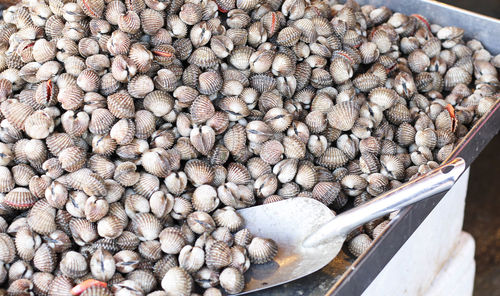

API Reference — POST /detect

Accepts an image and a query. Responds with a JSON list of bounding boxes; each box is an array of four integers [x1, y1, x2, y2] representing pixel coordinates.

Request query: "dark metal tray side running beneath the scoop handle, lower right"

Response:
[[328, 100, 500, 296]]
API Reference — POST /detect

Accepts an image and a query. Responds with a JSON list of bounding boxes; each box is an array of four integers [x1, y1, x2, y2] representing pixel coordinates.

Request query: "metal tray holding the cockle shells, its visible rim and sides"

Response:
[[252, 0, 500, 296]]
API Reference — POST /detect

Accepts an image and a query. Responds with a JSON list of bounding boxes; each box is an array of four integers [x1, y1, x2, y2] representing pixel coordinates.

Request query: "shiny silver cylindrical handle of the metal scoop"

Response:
[[302, 158, 466, 248]]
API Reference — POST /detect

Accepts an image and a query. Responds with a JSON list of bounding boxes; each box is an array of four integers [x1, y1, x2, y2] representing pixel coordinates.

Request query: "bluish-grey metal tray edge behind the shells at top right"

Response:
[[356, 0, 500, 55]]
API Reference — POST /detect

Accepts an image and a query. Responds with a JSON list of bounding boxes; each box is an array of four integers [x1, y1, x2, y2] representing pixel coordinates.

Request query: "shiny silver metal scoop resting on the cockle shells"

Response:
[[238, 158, 466, 294]]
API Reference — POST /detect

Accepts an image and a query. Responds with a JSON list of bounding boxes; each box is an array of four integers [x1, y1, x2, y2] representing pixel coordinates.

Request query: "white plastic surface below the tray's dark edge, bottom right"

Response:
[[362, 170, 474, 296]]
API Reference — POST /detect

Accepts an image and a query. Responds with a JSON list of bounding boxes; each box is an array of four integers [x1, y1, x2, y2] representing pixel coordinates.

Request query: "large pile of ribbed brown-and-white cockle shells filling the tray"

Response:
[[0, 0, 500, 296]]
